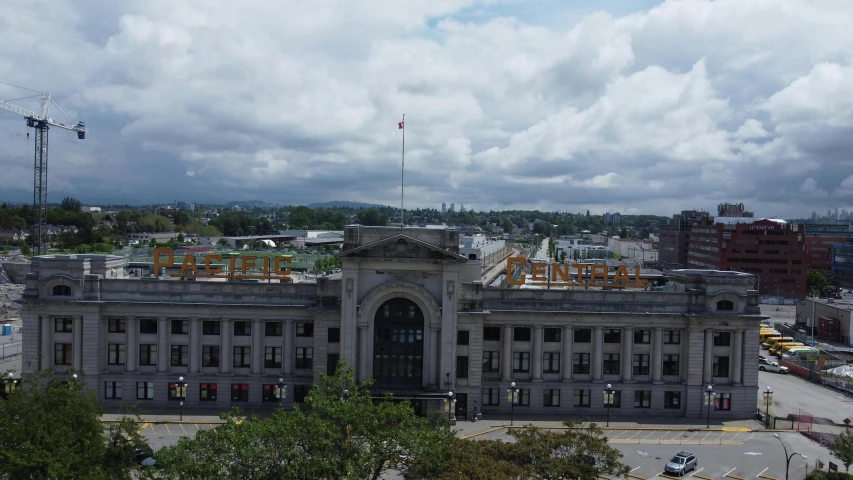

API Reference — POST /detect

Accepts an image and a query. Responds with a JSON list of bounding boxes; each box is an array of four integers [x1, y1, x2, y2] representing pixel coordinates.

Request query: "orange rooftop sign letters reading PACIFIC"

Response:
[[154, 248, 291, 280]]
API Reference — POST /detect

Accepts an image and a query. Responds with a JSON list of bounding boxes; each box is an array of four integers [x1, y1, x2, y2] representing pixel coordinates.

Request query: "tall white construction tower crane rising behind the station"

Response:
[[0, 92, 86, 255]]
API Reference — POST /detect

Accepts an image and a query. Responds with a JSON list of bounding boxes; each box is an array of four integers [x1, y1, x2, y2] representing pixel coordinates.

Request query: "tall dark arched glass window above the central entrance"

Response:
[[373, 298, 424, 387]]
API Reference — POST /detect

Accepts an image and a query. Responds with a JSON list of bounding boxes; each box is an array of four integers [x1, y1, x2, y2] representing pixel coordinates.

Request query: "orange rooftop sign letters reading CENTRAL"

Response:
[[506, 257, 649, 288]]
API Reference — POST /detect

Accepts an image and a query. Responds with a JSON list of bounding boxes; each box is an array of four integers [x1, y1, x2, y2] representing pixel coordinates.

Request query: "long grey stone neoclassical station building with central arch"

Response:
[[23, 226, 765, 418]]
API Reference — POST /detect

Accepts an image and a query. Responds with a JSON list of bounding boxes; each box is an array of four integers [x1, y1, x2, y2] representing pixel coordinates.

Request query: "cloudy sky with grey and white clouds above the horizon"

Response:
[[0, 0, 853, 217]]
